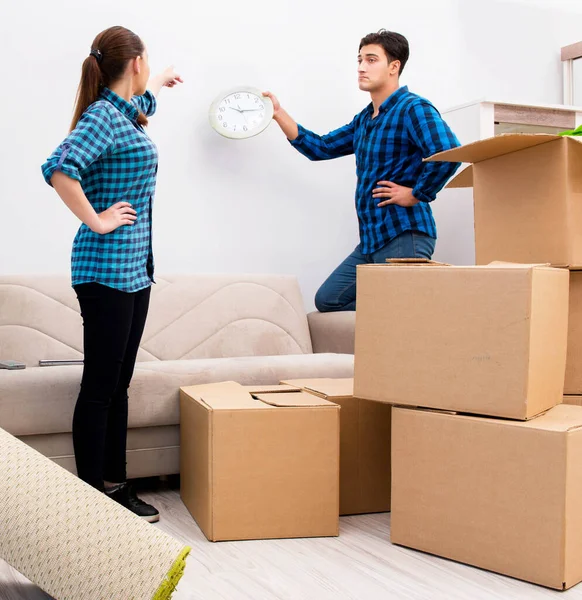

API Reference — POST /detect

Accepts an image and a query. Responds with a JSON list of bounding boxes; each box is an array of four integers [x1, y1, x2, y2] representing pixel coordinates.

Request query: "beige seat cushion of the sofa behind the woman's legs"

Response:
[[0, 354, 354, 435]]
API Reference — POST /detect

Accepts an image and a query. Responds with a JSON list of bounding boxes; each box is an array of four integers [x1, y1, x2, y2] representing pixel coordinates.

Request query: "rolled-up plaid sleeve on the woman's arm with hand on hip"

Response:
[[42, 105, 115, 185]]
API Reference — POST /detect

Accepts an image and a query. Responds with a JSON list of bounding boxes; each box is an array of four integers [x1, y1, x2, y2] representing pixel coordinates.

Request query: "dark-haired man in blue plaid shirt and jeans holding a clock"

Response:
[[265, 29, 459, 312]]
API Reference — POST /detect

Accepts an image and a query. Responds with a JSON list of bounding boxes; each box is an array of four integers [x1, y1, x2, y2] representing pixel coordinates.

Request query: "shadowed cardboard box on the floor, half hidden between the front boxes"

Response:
[[284, 378, 392, 515]]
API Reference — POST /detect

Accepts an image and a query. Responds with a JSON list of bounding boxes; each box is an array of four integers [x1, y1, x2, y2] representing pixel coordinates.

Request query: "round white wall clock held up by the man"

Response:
[[209, 87, 273, 139]]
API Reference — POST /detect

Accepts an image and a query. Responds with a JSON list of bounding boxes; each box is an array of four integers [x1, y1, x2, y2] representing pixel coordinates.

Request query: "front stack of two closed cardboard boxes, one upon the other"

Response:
[[354, 263, 582, 588]]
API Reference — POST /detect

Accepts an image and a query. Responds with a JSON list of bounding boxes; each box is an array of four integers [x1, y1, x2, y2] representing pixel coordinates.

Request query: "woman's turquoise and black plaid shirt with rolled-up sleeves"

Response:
[[42, 88, 158, 292]]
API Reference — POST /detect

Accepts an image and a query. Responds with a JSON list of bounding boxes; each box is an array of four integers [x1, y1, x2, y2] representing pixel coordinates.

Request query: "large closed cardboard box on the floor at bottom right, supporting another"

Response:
[[391, 405, 582, 590]]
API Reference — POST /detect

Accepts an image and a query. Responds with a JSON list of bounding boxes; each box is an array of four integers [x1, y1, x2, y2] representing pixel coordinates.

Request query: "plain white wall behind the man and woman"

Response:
[[0, 0, 582, 308]]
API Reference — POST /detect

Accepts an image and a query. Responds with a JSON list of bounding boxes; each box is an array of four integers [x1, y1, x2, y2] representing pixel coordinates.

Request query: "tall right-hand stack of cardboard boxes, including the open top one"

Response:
[[355, 135, 582, 589]]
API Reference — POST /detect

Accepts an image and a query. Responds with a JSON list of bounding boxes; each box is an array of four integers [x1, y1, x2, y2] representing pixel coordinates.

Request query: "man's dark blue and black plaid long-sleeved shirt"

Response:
[[291, 87, 459, 254]]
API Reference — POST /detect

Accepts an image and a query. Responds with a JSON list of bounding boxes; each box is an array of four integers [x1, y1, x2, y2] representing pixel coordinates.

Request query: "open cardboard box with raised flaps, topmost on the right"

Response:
[[427, 133, 582, 266]]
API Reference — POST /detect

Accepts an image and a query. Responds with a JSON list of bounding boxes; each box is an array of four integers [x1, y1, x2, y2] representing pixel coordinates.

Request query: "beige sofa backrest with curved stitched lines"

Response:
[[0, 274, 312, 366]]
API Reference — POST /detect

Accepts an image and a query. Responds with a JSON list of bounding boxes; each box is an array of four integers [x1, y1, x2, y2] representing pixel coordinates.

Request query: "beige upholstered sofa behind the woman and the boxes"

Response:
[[0, 275, 355, 478]]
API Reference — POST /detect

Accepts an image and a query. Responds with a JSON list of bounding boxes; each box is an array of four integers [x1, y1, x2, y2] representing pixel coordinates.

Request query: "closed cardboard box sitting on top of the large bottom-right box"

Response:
[[354, 264, 568, 419]]
